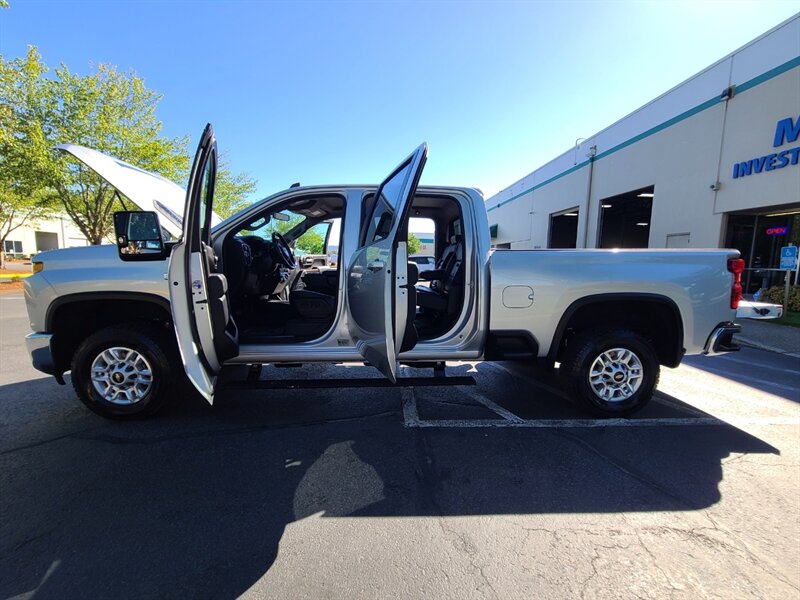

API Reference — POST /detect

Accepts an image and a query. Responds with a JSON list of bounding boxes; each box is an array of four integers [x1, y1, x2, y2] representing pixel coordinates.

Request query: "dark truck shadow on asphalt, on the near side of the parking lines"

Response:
[[0, 368, 778, 599]]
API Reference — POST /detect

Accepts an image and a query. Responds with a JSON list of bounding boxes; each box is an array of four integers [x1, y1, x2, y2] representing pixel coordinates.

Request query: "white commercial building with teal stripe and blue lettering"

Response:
[[486, 15, 800, 292]]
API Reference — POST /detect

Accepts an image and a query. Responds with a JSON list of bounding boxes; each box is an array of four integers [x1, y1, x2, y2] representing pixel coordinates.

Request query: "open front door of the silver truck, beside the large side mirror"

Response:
[[169, 124, 238, 403]]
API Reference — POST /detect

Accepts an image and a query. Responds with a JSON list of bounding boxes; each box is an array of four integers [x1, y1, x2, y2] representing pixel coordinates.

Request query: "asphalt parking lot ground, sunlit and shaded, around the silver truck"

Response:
[[0, 295, 800, 599]]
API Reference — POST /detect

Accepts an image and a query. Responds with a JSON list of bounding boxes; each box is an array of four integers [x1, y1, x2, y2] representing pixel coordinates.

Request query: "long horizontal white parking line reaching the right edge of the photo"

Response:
[[406, 417, 800, 429]]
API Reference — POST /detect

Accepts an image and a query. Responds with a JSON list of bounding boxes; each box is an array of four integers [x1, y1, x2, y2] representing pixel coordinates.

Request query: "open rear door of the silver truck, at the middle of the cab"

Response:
[[347, 144, 428, 382]]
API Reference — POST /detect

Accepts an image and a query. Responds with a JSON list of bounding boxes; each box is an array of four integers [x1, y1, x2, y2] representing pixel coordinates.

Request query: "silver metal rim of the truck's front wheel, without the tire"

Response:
[[90, 346, 153, 405]]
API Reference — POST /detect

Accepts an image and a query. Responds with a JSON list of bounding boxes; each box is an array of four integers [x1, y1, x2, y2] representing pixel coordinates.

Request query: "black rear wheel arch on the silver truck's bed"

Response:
[[548, 292, 685, 367]]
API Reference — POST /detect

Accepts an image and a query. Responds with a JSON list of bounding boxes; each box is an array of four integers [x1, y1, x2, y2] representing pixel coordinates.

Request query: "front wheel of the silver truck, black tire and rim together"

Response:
[[72, 323, 175, 420]]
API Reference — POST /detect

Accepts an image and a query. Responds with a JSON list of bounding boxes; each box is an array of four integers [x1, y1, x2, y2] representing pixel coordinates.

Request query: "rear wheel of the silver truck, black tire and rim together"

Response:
[[559, 328, 660, 417]]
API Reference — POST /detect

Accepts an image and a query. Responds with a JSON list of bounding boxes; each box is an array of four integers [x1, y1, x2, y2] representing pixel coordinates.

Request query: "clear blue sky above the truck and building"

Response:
[[0, 0, 800, 202]]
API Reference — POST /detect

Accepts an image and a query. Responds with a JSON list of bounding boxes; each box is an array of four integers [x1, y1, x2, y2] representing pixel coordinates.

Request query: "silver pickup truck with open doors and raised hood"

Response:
[[25, 126, 743, 418]]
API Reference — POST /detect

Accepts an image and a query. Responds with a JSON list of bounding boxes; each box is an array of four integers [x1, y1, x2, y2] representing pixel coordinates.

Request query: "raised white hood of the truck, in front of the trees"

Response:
[[57, 144, 222, 239]]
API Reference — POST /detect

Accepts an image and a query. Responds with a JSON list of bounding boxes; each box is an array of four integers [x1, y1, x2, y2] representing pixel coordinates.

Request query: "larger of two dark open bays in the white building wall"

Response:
[[597, 186, 655, 248]]
